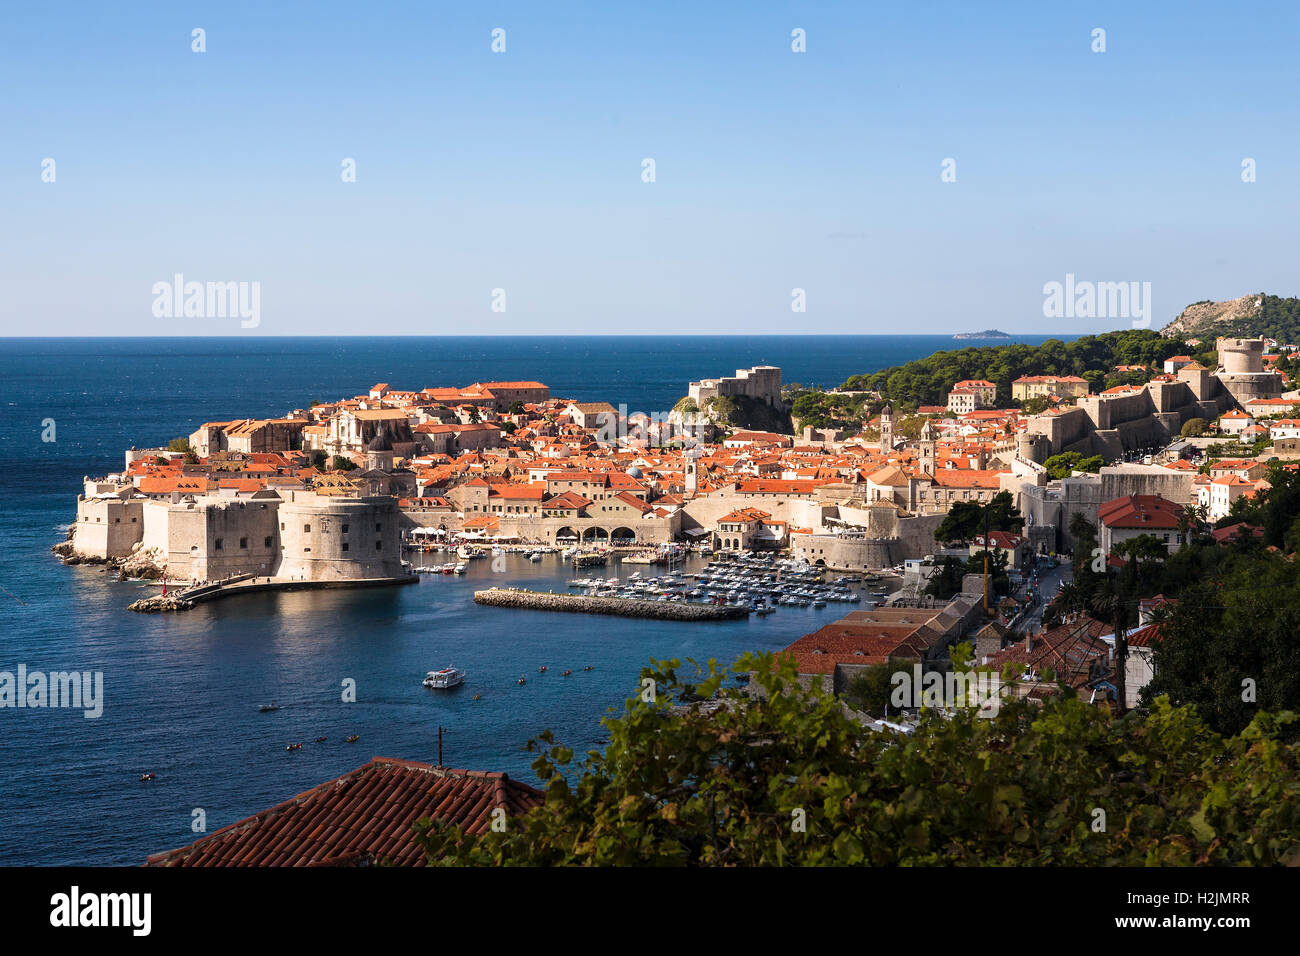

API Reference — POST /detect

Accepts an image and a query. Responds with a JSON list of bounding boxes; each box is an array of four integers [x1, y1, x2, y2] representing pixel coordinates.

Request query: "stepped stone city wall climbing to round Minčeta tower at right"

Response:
[[1017, 338, 1282, 463]]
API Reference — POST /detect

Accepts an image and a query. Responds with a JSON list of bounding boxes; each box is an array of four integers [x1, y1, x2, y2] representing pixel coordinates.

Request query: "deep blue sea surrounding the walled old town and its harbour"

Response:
[[0, 336, 1047, 865]]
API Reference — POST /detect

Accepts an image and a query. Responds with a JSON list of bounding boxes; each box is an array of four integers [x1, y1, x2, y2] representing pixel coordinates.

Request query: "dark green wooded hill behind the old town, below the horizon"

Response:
[[841, 329, 1196, 407]]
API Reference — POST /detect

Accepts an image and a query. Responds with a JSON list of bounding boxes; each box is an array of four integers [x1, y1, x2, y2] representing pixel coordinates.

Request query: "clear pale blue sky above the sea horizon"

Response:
[[0, 0, 1300, 336]]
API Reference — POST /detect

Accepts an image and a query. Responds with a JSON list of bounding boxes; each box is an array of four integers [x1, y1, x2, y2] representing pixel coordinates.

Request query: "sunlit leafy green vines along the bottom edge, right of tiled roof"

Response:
[[416, 654, 1300, 866]]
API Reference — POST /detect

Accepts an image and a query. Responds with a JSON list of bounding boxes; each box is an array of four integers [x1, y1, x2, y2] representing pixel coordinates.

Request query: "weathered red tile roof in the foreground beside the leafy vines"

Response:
[[146, 757, 545, 866]]
